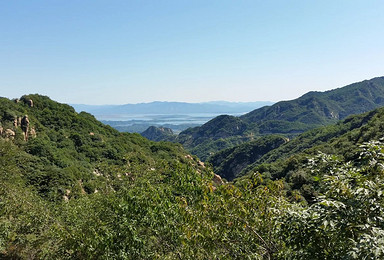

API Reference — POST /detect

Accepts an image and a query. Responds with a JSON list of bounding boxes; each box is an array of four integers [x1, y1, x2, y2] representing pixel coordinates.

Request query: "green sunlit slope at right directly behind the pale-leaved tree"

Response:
[[234, 105, 384, 201]]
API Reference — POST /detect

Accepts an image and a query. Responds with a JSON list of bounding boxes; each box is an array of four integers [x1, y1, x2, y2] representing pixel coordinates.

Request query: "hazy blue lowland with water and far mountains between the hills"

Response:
[[72, 101, 273, 133]]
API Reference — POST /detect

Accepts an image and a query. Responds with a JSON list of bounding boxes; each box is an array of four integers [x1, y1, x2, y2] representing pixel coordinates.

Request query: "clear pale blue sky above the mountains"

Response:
[[0, 0, 384, 104]]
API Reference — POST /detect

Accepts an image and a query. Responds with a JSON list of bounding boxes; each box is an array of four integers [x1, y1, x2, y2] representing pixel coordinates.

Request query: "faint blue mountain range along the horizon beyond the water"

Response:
[[71, 101, 273, 117]]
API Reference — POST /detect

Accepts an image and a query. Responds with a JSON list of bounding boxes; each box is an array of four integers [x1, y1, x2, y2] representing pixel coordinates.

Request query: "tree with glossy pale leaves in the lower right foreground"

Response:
[[279, 141, 384, 259]]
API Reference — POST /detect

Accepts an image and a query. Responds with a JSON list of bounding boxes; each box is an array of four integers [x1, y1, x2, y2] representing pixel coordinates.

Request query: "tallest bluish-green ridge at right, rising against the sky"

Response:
[[240, 77, 384, 125]]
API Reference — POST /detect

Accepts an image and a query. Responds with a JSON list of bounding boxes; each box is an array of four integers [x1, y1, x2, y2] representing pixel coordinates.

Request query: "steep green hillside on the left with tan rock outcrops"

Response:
[[0, 95, 204, 200]]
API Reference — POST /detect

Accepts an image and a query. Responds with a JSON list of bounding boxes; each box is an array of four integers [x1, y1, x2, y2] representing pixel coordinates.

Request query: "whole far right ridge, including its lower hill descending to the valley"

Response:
[[177, 77, 384, 160]]
